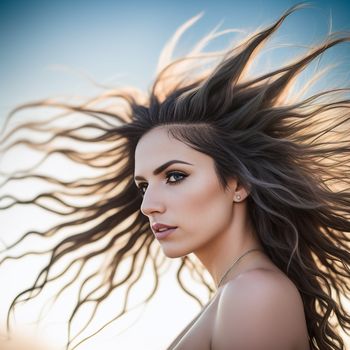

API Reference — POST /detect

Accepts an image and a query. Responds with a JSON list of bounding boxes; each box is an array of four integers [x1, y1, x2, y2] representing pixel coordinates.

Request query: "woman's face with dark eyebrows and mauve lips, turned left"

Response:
[[135, 127, 235, 257]]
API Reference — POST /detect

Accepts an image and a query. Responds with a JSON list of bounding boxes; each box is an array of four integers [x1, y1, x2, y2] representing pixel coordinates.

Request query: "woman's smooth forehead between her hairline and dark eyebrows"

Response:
[[135, 127, 211, 174]]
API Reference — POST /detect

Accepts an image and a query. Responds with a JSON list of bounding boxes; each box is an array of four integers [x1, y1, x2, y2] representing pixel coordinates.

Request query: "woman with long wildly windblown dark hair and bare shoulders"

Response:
[[3, 6, 350, 350]]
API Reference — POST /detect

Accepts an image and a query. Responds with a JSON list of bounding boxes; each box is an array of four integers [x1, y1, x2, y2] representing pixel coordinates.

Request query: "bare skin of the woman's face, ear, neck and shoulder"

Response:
[[135, 126, 309, 350]]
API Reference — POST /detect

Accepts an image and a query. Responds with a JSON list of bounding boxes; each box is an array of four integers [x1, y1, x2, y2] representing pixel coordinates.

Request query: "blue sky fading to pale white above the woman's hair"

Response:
[[0, 0, 350, 114]]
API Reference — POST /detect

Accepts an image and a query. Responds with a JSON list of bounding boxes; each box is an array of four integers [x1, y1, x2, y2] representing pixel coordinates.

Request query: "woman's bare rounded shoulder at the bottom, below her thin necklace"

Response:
[[212, 269, 308, 350]]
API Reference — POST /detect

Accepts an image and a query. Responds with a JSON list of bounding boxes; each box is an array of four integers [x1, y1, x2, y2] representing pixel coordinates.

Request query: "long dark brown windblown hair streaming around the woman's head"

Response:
[[1, 6, 350, 350]]
